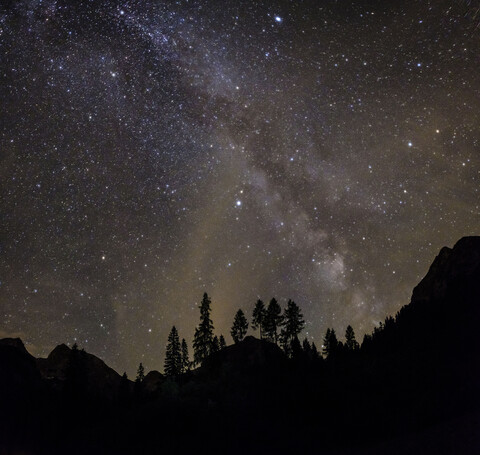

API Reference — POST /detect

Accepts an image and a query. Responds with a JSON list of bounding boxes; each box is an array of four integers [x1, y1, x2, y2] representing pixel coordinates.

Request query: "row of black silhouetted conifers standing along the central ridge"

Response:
[[135, 293, 360, 385]]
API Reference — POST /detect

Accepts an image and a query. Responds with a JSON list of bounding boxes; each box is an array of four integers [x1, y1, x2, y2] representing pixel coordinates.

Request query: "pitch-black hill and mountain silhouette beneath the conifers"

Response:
[[0, 237, 480, 455]]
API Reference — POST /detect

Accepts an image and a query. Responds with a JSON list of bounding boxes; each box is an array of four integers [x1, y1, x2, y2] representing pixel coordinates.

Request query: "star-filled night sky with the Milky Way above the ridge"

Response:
[[0, 0, 480, 376]]
